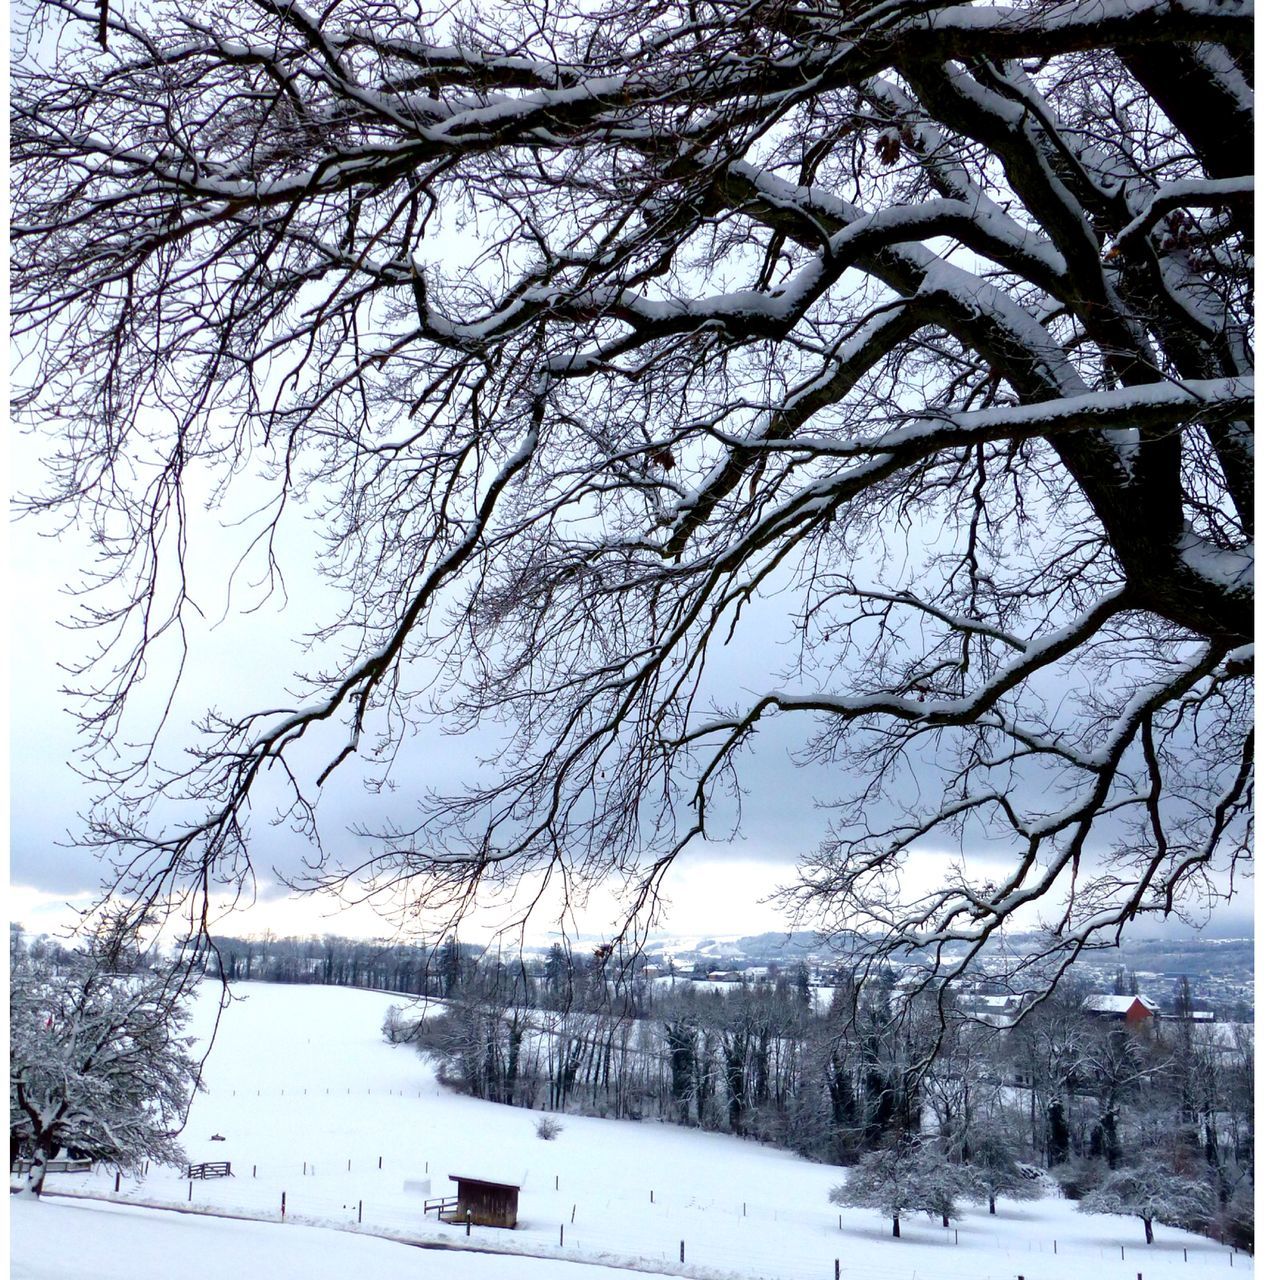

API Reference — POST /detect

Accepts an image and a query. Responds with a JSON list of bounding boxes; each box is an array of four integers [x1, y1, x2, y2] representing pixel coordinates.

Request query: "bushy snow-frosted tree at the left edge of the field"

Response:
[[9, 940, 198, 1196]]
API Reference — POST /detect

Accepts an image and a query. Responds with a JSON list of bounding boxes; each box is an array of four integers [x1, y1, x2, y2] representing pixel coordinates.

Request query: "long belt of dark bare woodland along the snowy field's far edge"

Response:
[[387, 951, 1253, 1243]]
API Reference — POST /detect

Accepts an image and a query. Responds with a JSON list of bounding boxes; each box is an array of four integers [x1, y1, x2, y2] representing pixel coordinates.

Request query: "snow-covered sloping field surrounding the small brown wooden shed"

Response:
[[10, 983, 1253, 1280]]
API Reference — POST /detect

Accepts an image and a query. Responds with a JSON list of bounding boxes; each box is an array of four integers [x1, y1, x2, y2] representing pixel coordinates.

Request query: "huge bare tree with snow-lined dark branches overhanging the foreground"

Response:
[[13, 0, 1253, 998]]
